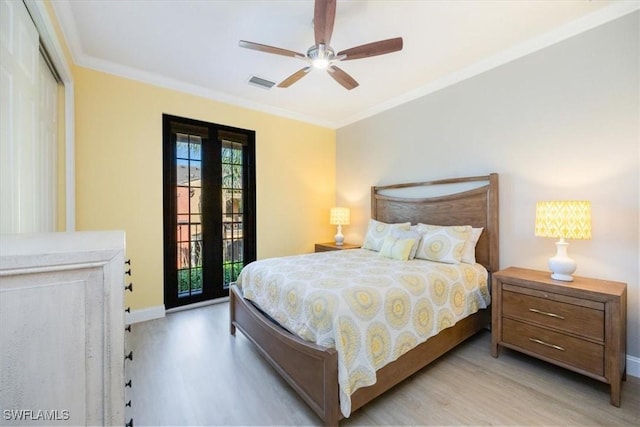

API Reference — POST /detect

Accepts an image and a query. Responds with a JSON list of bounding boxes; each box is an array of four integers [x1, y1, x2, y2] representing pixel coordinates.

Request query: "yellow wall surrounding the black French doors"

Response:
[[73, 67, 336, 309]]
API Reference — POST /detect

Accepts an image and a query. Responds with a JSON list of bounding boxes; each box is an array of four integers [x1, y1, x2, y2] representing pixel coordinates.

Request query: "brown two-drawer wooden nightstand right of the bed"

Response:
[[491, 267, 627, 406]]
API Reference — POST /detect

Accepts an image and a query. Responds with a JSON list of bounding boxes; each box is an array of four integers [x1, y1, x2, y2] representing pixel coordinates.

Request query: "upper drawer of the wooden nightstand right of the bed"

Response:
[[502, 290, 604, 342]]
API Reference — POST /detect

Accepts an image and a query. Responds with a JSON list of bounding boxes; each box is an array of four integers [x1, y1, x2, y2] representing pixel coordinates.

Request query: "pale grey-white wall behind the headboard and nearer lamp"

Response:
[[336, 12, 640, 361]]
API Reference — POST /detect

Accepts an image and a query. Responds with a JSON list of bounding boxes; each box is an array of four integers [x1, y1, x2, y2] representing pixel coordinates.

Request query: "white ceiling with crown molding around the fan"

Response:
[[52, 0, 638, 128]]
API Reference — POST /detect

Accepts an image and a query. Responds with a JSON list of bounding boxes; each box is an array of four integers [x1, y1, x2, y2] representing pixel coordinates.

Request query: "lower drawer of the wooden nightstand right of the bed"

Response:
[[502, 319, 604, 376]]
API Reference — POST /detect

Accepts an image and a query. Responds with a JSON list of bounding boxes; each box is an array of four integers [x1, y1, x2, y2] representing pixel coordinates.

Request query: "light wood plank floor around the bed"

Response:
[[126, 303, 640, 426]]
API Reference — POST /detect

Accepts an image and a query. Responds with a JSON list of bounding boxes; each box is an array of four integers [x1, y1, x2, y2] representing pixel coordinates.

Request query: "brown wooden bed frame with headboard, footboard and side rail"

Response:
[[229, 173, 499, 425]]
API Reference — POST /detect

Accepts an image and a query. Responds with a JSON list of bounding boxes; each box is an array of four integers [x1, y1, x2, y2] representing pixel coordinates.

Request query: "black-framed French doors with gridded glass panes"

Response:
[[163, 114, 256, 309]]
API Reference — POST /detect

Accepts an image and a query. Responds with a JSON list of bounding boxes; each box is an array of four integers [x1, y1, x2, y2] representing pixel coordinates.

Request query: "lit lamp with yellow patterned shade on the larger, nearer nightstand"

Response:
[[535, 200, 591, 282]]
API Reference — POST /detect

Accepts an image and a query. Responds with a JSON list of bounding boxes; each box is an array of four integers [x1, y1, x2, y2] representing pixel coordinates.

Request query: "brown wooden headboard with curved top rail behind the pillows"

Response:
[[371, 173, 500, 273]]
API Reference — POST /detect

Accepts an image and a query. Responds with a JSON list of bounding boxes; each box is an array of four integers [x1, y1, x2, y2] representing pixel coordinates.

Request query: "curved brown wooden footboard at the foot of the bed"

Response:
[[229, 285, 341, 426]]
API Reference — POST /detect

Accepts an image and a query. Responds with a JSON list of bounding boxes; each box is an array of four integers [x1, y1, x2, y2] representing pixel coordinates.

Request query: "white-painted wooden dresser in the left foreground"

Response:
[[0, 231, 125, 426]]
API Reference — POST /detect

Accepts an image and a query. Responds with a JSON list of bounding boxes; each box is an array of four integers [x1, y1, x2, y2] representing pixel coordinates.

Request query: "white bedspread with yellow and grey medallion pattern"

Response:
[[238, 249, 490, 417]]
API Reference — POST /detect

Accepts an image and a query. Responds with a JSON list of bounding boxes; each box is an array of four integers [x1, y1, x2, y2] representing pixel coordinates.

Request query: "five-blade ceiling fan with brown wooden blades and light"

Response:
[[240, 0, 402, 90]]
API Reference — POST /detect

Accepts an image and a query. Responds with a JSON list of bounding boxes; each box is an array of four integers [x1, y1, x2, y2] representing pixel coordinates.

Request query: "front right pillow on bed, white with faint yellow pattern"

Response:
[[416, 224, 471, 264]]
